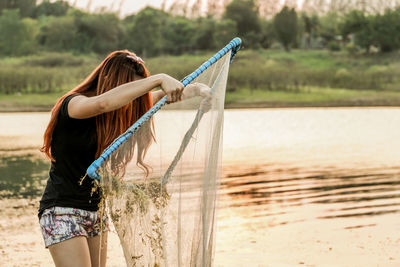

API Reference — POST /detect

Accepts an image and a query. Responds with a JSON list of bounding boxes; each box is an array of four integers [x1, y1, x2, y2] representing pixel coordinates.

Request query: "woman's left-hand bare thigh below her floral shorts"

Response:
[[49, 236, 91, 267]]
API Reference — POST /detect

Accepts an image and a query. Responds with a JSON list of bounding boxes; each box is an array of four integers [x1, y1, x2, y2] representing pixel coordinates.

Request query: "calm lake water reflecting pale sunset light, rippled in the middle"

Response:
[[0, 108, 400, 266]]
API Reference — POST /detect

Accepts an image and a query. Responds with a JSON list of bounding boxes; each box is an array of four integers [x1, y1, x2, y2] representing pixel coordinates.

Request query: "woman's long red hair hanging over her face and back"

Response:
[[41, 50, 154, 163]]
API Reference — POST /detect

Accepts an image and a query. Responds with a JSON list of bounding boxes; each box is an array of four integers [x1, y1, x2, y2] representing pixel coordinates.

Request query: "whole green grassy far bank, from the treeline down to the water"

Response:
[[0, 49, 400, 111]]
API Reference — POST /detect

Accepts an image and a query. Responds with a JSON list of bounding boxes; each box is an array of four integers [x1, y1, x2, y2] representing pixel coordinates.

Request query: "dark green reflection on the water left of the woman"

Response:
[[0, 154, 49, 198]]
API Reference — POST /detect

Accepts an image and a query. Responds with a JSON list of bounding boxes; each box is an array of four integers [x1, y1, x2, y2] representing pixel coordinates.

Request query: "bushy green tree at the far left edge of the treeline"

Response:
[[0, 9, 38, 56]]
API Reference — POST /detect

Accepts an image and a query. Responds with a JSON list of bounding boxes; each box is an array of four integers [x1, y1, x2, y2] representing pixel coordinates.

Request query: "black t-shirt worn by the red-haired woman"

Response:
[[39, 95, 100, 217]]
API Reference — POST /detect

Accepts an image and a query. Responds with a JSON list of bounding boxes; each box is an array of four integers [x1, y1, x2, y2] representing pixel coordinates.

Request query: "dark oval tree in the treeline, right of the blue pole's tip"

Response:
[[274, 6, 297, 52]]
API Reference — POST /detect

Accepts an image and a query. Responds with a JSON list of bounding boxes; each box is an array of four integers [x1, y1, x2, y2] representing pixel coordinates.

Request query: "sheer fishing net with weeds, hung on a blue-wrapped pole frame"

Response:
[[88, 38, 241, 266]]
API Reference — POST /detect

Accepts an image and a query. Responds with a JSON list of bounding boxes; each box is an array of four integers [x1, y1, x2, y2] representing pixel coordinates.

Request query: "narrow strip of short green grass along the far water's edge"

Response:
[[0, 88, 400, 112]]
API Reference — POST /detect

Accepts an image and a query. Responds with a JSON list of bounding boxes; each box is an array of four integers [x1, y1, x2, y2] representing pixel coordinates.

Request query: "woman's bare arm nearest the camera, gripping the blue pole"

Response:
[[68, 74, 184, 119]]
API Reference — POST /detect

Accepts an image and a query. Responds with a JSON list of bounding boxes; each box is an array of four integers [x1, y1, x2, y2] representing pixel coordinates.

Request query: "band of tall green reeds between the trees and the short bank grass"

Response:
[[0, 49, 400, 97]]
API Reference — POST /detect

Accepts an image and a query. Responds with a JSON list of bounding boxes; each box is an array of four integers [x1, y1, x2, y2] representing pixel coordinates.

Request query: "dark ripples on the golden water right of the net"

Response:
[[221, 165, 400, 224]]
